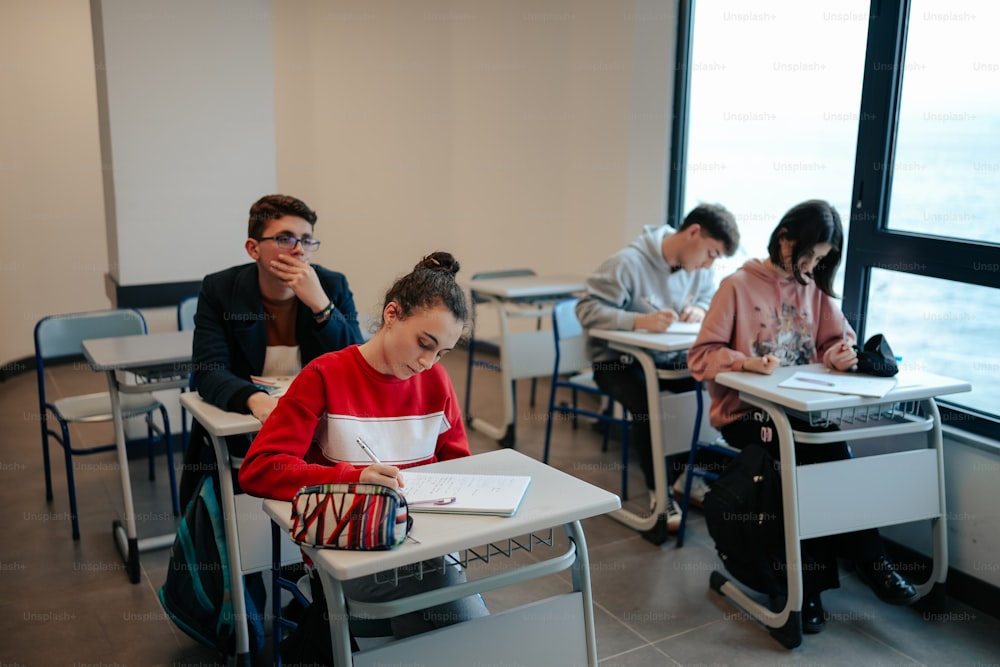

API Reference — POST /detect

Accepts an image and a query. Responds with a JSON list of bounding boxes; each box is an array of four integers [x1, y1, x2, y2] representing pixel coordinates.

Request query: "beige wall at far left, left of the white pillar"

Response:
[[0, 0, 109, 376]]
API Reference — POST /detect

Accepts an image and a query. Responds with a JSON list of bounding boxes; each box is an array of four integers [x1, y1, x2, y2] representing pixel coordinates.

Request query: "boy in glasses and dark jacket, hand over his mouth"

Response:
[[194, 195, 362, 434]]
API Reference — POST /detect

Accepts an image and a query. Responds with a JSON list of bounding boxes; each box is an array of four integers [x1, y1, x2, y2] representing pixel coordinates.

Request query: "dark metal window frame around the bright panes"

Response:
[[666, 0, 1000, 440]]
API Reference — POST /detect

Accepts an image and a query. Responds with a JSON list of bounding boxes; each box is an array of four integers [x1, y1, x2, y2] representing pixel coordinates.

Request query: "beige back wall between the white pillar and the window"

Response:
[[273, 0, 675, 318]]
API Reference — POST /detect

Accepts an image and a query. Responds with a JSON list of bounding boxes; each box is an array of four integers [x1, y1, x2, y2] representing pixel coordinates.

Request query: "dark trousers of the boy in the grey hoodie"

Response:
[[593, 358, 694, 489]]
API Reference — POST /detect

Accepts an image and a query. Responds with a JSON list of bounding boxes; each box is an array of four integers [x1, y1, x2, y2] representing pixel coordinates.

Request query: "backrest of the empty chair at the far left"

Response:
[[35, 308, 146, 363]]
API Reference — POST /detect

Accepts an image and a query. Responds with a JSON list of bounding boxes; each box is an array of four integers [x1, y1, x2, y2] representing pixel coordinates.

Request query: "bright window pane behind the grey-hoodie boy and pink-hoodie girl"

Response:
[[683, 0, 868, 290]]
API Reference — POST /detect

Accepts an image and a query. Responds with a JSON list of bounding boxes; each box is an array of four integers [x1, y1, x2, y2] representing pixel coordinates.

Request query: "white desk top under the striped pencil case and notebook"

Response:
[[264, 449, 621, 580]]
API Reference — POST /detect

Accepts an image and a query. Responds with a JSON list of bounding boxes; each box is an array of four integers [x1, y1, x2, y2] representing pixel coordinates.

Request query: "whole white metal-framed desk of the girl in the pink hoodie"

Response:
[[710, 364, 971, 648]]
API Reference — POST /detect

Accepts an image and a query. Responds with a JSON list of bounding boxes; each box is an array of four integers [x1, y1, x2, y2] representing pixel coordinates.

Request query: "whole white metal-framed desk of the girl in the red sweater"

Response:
[[264, 449, 621, 666]]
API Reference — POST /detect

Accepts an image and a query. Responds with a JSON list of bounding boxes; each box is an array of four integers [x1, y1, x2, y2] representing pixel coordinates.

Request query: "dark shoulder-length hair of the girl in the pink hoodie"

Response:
[[767, 199, 844, 298]]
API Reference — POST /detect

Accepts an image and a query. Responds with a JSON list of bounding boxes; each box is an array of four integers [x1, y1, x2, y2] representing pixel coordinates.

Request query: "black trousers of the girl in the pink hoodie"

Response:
[[722, 410, 885, 595]]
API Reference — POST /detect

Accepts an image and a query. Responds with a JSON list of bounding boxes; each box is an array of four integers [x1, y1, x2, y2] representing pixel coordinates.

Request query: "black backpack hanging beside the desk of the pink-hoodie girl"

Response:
[[703, 443, 787, 595]]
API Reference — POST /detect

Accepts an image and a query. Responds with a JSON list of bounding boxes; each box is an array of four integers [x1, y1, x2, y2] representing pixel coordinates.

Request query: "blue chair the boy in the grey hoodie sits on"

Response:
[[542, 298, 629, 500]]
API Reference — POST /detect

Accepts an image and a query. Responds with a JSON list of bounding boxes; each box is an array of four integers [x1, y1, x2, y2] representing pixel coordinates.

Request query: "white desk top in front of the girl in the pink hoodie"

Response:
[[715, 364, 972, 412]]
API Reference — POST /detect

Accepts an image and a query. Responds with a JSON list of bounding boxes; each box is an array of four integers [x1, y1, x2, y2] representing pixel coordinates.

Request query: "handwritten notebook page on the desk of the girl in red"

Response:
[[402, 470, 531, 516]]
